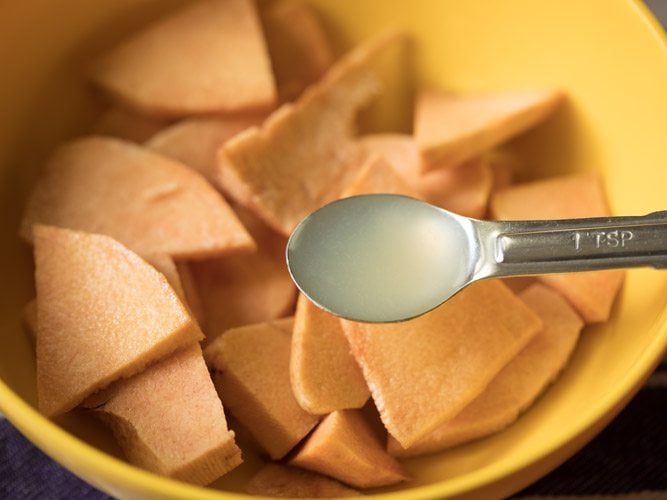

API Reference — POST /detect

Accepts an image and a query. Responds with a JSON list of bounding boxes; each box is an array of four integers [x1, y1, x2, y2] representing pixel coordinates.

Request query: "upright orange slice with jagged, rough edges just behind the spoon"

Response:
[[219, 34, 396, 235]]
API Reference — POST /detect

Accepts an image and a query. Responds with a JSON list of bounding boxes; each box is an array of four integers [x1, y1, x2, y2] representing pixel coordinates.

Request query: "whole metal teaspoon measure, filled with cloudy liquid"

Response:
[[287, 194, 667, 322]]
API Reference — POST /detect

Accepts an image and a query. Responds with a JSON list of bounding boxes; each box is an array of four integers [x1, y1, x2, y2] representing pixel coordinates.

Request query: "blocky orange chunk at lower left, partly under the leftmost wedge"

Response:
[[96, 344, 242, 485]]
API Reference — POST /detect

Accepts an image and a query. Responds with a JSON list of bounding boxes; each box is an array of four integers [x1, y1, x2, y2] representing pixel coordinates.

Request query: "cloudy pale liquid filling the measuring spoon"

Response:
[[287, 195, 472, 322]]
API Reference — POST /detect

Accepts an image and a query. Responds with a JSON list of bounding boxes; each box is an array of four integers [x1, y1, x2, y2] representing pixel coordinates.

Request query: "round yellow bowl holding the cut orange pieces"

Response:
[[0, 0, 667, 499]]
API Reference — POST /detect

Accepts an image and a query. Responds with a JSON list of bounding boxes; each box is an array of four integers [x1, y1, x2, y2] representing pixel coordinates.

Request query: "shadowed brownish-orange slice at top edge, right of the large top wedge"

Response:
[[263, 0, 334, 101]]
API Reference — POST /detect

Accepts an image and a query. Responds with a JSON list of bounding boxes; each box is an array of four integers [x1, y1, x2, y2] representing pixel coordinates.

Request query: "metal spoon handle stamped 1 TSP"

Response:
[[477, 211, 667, 277]]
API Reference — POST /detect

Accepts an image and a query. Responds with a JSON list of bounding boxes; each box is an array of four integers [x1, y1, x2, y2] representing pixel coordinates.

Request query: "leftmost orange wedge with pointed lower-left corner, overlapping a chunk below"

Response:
[[35, 226, 203, 416]]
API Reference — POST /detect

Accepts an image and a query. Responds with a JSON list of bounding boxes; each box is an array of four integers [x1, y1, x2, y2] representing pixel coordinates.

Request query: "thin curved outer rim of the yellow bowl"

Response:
[[0, 0, 667, 500]]
